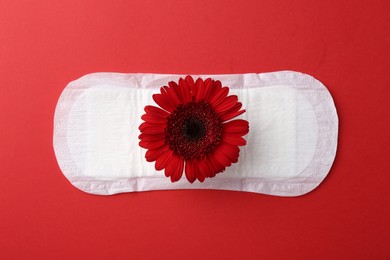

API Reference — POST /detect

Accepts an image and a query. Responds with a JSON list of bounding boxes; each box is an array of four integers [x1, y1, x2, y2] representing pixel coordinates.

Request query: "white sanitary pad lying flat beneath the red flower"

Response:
[[53, 71, 338, 196]]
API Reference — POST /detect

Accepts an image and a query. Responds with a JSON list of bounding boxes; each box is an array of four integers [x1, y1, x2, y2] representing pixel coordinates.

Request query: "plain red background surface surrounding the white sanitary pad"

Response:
[[0, 0, 390, 259]]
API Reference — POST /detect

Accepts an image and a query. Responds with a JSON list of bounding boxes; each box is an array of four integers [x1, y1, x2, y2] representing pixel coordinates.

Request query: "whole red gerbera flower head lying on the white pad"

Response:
[[139, 76, 249, 183]]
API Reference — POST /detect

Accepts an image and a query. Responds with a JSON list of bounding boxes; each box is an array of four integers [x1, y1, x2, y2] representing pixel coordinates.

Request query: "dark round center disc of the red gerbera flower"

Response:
[[165, 101, 222, 160]]
